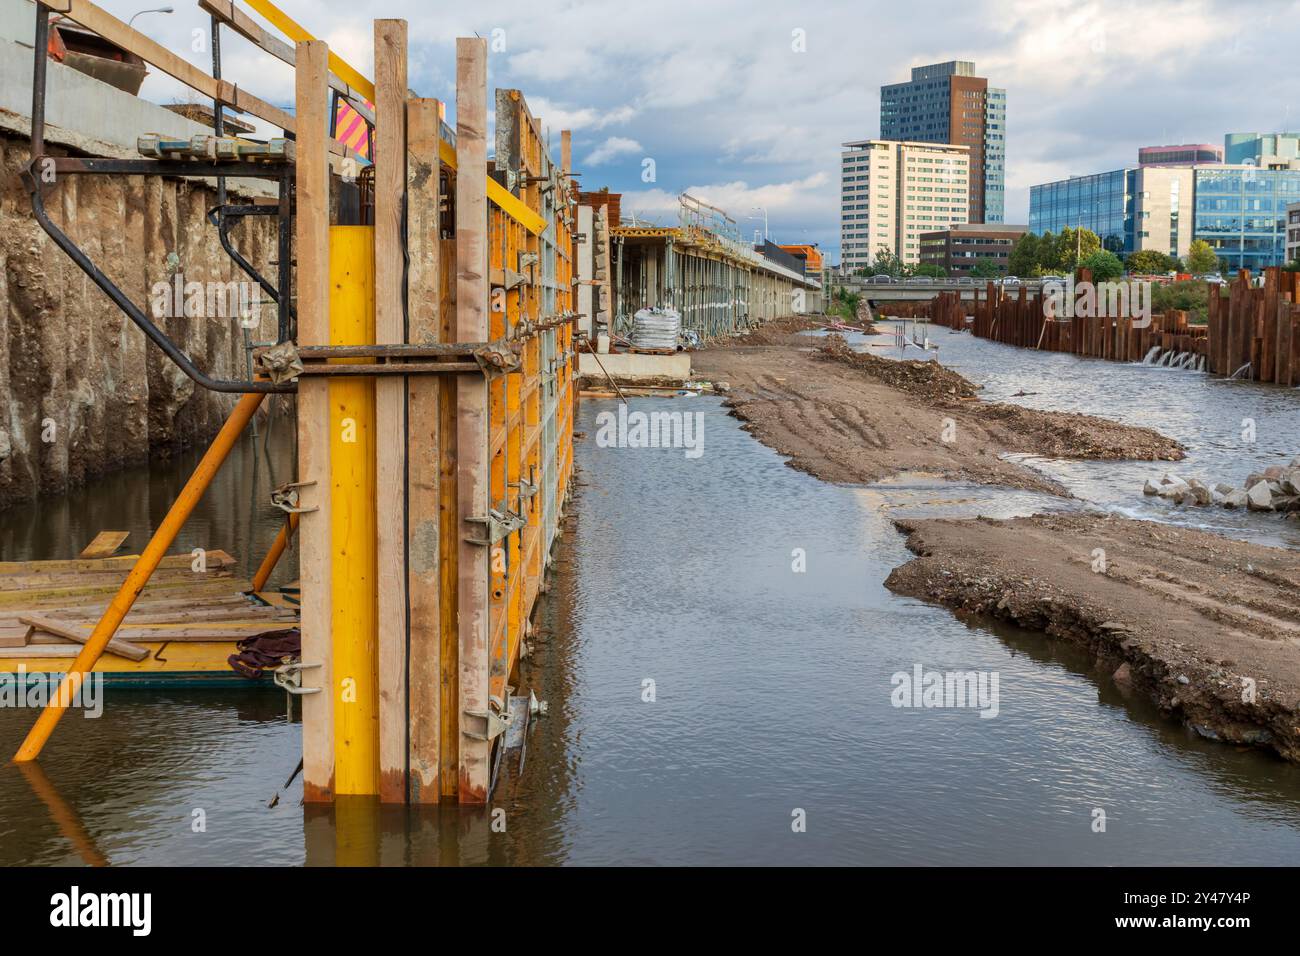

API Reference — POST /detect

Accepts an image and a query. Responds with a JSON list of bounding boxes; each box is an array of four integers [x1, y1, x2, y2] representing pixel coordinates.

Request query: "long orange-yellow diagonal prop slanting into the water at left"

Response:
[[14, 392, 267, 763]]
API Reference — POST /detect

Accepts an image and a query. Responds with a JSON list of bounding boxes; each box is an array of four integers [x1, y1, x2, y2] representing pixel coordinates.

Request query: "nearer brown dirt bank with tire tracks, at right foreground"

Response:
[[885, 515, 1300, 761]]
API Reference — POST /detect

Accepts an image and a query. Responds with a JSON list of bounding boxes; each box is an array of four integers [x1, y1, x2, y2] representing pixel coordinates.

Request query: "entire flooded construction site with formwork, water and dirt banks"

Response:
[[0, 0, 1300, 905]]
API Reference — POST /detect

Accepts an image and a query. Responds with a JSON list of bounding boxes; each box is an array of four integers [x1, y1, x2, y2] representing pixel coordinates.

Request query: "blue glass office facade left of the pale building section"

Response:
[[1030, 169, 1136, 252]]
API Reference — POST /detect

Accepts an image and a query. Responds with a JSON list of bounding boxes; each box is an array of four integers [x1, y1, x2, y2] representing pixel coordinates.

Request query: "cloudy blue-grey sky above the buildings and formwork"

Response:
[[100, 0, 1300, 260]]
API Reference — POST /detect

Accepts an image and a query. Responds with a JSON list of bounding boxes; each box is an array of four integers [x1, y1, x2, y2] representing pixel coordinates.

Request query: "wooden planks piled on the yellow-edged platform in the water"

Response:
[[0, 551, 298, 661]]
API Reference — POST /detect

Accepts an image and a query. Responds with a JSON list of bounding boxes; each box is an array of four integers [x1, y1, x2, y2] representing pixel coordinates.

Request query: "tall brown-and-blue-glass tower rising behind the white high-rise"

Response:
[[880, 60, 1006, 222]]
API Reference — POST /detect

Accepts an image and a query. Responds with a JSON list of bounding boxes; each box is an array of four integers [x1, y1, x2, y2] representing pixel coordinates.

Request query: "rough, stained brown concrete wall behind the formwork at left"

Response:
[[0, 134, 276, 507]]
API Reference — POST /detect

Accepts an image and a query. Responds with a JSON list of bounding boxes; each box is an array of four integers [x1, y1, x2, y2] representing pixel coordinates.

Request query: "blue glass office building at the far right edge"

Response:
[[1192, 166, 1300, 271]]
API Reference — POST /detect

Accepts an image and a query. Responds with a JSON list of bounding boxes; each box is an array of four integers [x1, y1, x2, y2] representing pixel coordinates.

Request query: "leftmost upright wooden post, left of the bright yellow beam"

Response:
[[294, 40, 337, 803]]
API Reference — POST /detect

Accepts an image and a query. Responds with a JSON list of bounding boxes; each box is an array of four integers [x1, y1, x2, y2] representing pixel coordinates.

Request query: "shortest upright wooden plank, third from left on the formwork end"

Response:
[[406, 99, 445, 804]]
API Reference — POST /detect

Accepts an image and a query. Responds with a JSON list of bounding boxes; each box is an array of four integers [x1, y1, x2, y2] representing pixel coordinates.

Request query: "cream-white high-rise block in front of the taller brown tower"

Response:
[[840, 139, 971, 271]]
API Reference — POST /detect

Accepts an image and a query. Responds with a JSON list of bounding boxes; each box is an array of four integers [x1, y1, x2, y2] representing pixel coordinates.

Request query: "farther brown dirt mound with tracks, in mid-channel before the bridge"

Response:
[[693, 327, 1183, 494]]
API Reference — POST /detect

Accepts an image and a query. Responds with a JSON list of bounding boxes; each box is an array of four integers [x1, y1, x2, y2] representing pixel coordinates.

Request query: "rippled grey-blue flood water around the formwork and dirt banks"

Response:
[[0, 330, 1300, 865]]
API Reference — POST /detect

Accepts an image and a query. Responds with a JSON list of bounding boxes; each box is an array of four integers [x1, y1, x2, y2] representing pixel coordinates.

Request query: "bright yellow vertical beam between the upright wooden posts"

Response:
[[329, 226, 379, 796]]
